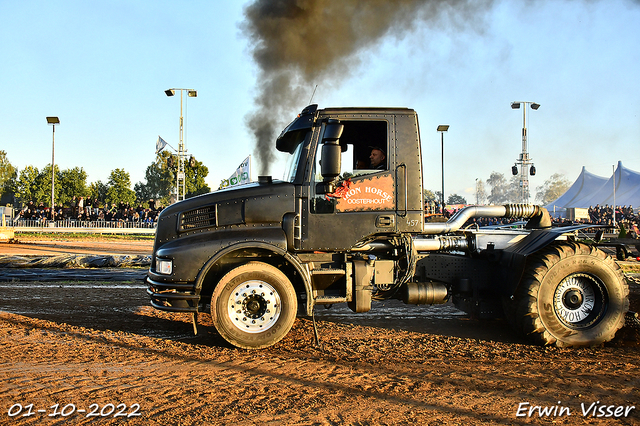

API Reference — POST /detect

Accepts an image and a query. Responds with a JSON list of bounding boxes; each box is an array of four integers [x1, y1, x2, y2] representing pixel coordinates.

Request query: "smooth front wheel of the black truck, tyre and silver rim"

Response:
[[211, 262, 298, 349]]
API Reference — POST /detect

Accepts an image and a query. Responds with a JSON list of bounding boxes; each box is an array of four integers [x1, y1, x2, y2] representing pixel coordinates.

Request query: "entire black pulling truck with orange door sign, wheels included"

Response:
[[146, 105, 629, 349]]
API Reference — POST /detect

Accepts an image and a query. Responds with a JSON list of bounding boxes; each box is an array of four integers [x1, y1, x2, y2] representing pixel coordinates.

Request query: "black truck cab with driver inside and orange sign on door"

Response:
[[276, 106, 424, 251]]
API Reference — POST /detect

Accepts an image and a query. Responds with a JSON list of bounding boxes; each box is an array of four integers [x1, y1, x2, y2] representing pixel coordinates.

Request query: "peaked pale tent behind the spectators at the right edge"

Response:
[[545, 161, 640, 215]]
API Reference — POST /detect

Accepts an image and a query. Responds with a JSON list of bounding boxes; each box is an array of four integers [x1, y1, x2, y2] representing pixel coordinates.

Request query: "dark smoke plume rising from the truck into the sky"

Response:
[[241, 0, 493, 175]]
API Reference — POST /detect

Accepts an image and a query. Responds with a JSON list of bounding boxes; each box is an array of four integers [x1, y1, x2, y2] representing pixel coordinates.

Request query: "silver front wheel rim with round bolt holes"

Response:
[[227, 280, 282, 333]]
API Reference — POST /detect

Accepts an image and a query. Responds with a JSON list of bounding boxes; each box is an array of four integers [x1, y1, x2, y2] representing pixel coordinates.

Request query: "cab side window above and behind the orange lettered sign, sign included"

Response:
[[311, 120, 394, 213]]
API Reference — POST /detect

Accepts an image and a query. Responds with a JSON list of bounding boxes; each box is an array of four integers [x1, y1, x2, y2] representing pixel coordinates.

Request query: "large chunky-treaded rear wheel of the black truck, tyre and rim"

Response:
[[505, 242, 629, 347]]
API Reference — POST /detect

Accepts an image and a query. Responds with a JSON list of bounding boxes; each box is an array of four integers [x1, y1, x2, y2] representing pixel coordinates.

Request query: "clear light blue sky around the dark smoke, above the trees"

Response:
[[0, 0, 640, 201]]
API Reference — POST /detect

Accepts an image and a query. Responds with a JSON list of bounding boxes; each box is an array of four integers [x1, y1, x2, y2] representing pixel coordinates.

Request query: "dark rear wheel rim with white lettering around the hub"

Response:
[[553, 274, 606, 329]]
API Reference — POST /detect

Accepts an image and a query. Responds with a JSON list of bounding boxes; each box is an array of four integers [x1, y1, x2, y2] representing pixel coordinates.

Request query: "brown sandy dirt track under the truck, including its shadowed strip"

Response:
[[0, 238, 640, 425]]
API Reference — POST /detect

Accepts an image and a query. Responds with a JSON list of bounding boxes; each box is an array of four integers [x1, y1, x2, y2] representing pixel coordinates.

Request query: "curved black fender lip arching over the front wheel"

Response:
[[195, 241, 313, 316]]
